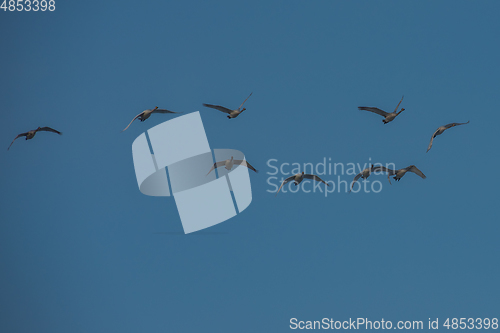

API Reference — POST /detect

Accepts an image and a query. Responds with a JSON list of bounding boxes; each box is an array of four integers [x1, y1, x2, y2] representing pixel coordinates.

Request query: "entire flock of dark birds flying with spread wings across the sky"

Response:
[[7, 93, 469, 195]]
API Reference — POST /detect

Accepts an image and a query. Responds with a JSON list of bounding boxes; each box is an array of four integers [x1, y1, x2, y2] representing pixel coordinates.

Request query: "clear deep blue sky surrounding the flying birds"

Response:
[[0, 0, 500, 332]]
